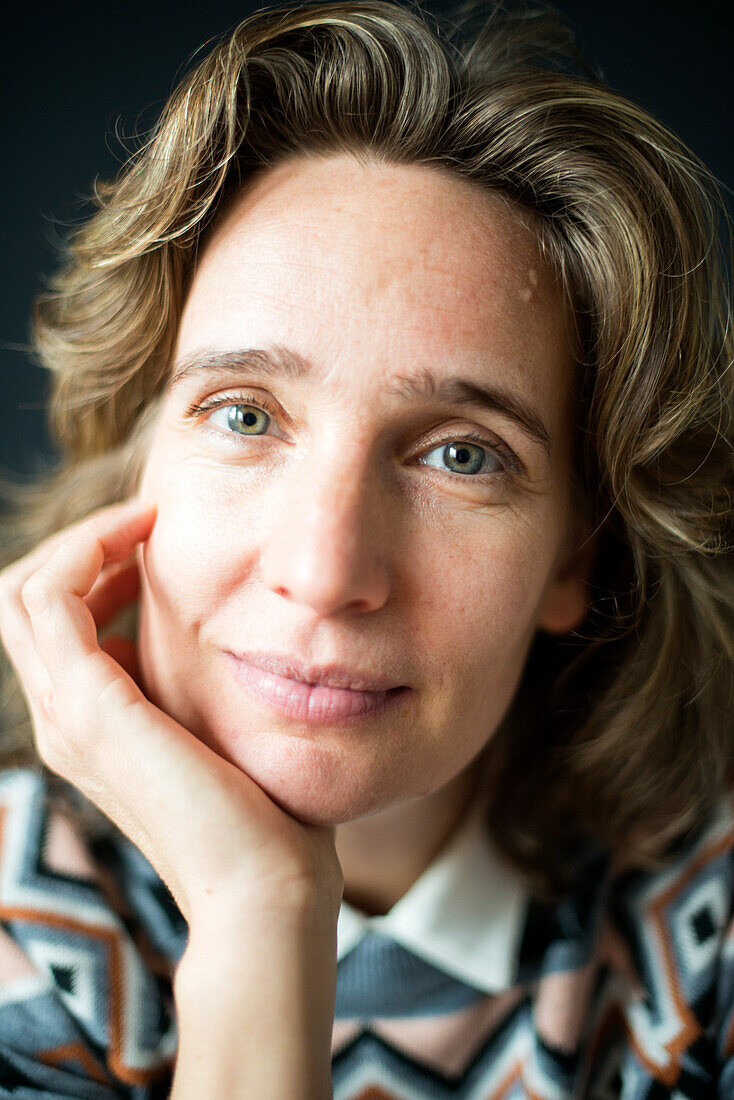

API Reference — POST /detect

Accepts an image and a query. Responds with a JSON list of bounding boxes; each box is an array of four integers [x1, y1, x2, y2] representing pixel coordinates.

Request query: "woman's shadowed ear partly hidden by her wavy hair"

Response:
[[537, 517, 599, 634]]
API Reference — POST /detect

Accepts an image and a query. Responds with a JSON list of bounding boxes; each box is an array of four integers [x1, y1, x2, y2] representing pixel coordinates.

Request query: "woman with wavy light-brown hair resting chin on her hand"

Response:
[[0, 0, 734, 1100]]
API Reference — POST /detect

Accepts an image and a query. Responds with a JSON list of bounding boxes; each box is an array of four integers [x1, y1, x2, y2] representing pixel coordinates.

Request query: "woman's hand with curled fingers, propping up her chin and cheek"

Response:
[[0, 498, 343, 925]]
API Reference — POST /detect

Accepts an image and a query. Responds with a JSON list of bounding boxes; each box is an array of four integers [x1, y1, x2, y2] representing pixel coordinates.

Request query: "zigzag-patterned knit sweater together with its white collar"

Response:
[[0, 769, 734, 1100]]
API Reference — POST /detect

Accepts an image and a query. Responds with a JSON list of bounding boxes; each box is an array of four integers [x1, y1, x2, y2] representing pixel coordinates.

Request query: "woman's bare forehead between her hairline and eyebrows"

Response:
[[178, 155, 568, 422]]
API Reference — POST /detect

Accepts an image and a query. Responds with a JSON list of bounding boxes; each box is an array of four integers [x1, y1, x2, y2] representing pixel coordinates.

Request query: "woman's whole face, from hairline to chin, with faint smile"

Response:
[[140, 156, 585, 825]]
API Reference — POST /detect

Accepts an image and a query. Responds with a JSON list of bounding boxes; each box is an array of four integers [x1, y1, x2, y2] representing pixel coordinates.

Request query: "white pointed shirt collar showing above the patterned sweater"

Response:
[[337, 800, 529, 993]]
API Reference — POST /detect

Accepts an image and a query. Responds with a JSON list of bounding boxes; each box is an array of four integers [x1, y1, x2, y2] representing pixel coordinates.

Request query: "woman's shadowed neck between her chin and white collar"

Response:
[[336, 761, 480, 916]]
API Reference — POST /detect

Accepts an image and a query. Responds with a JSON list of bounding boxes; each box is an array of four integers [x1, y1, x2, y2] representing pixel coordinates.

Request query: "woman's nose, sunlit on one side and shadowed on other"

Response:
[[260, 448, 391, 615]]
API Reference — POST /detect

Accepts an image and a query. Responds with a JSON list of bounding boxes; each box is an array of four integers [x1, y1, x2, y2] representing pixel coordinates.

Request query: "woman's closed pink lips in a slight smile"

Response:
[[224, 650, 410, 725]]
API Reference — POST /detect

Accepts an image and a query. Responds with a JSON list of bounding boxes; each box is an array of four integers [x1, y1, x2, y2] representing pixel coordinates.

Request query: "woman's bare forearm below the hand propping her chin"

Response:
[[172, 897, 337, 1100]]
